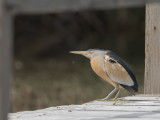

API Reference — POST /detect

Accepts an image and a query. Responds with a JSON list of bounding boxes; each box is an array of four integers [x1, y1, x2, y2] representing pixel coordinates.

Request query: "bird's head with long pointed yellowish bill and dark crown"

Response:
[[70, 49, 104, 59]]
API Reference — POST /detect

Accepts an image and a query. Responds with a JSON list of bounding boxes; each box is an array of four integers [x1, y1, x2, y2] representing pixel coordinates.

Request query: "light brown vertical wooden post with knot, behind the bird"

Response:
[[144, 3, 160, 94]]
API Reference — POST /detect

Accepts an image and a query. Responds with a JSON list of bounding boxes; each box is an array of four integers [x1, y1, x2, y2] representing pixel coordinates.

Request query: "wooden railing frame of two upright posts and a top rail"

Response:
[[0, 0, 160, 120]]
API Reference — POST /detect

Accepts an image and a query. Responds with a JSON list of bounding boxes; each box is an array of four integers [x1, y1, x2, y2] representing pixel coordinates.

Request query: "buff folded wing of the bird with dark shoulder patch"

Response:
[[104, 55, 134, 86]]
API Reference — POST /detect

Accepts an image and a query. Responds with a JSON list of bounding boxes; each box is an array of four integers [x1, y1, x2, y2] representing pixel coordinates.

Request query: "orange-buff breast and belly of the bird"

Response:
[[90, 58, 120, 88]]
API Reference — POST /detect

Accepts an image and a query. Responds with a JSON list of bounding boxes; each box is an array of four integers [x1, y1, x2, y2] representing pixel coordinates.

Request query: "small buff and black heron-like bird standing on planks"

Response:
[[70, 49, 138, 100]]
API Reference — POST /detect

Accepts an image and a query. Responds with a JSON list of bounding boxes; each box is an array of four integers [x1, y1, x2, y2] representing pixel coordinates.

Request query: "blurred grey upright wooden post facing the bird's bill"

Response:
[[0, 0, 12, 120]]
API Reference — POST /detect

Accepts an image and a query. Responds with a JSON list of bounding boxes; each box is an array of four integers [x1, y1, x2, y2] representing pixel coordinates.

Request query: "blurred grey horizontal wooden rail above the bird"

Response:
[[8, 0, 160, 14]]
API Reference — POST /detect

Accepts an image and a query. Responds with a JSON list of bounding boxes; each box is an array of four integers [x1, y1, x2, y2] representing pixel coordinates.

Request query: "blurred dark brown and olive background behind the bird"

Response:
[[11, 7, 145, 112]]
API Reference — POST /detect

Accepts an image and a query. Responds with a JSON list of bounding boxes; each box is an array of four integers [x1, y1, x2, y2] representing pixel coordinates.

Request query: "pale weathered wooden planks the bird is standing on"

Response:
[[9, 95, 160, 120]]
